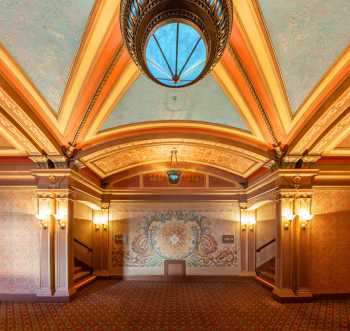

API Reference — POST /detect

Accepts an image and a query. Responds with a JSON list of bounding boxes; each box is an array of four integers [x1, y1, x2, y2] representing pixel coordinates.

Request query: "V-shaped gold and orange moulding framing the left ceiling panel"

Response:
[[0, 0, 122, 141]]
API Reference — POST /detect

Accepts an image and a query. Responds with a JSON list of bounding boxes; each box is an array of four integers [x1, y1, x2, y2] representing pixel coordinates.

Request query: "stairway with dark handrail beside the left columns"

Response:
[[73, 239, 96, 290]]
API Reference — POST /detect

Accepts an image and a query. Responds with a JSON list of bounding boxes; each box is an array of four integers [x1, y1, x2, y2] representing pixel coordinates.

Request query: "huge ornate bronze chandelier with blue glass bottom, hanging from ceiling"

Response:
[[120, 0, 232, 88]]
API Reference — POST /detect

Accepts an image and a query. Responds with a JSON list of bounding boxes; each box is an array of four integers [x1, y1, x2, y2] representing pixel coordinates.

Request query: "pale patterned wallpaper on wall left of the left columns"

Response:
[[0, 190, 40, 293]]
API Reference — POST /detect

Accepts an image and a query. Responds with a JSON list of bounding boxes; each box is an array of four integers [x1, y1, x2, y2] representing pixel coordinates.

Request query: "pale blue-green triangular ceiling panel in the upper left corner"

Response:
[[0, 0, 94, 111]]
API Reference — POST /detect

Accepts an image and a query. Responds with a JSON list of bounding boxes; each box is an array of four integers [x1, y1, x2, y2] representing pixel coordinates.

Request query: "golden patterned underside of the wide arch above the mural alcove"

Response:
[[79, 136, 268, 178]]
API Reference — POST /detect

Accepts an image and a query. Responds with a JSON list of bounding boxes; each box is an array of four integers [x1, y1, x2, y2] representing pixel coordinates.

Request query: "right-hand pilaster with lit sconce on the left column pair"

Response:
[[55, 190, 75, 297]]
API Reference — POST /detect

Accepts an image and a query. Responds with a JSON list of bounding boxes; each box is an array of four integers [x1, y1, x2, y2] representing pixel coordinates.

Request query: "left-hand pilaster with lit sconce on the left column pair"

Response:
[[36, 191, 55, 297]]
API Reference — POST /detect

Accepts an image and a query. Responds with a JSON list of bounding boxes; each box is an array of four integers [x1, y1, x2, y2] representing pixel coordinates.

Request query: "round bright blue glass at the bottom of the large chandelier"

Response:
[[145, 22, 207, 87]]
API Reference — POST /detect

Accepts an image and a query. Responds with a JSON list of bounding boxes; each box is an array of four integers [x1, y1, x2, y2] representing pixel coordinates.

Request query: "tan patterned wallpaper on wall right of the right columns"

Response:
[[311, 189, 350, 293]]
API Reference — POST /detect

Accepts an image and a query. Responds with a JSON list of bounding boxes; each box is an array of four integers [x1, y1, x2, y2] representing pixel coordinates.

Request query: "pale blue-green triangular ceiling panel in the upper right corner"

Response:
[[259, 0, 350, 112]]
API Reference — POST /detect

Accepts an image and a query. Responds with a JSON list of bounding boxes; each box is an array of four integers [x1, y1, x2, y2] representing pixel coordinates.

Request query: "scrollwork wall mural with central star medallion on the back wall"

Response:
[[112, 210, 238, 268]]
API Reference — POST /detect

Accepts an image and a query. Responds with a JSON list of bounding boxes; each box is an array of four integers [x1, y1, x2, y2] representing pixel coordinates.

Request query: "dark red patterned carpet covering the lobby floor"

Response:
[[0, 279, 350, 331]]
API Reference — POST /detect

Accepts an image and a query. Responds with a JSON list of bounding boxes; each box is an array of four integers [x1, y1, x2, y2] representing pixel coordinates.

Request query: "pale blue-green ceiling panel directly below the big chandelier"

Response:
[[102, 76, 249, 131]]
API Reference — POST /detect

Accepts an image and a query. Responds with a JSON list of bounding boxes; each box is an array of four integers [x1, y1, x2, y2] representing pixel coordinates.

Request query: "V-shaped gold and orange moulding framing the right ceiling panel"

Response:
[[234, 0, 350, 139]]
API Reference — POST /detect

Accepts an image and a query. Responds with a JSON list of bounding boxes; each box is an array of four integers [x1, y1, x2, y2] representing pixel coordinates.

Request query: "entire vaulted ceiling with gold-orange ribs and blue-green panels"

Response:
[[0, 0, 350, 177]]
